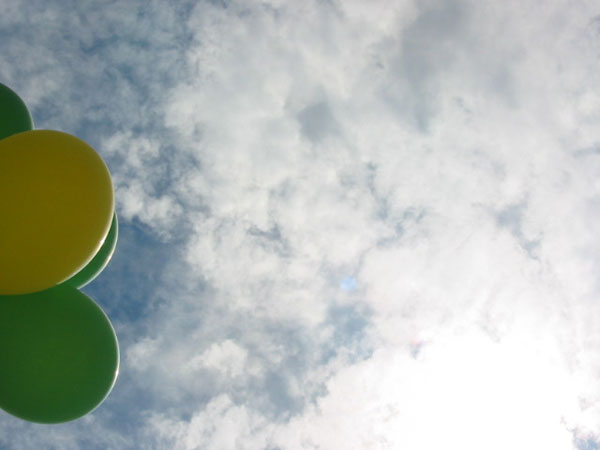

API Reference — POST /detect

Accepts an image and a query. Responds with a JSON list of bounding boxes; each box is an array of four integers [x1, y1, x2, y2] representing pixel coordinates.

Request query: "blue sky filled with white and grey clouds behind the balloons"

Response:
[[0, 0, 600, 450]]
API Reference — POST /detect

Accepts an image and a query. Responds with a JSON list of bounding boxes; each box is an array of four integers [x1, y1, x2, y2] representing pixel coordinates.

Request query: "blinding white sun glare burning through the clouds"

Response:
[[392, 326, 577, 450]]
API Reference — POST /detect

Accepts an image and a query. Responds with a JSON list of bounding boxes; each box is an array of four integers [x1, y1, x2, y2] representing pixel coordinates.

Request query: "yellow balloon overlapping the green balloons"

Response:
[[0, 130, 114, 295]]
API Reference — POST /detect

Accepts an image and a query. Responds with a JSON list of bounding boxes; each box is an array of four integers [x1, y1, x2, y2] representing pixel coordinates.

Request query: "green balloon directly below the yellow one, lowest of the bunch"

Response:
[[0, 285, 119, 423]]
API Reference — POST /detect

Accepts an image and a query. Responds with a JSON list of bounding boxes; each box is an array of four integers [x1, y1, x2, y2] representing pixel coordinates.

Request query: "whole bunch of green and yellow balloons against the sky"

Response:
[[0, 84, 119, 423]]
